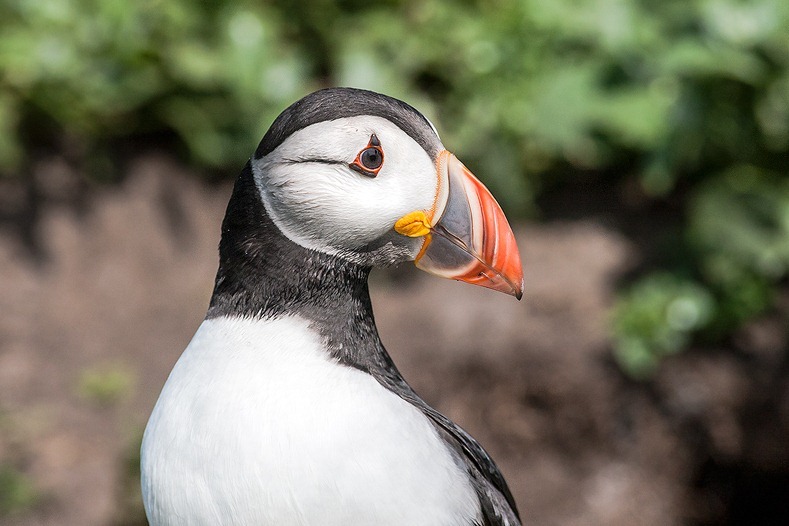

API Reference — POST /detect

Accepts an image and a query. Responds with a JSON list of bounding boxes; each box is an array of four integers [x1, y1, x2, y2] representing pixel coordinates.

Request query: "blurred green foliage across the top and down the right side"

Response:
[[0, 0, 789, 375]]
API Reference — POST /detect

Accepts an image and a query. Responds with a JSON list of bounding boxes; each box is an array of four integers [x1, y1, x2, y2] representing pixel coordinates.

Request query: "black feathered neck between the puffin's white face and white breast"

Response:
[[207, 163, 392, 370]]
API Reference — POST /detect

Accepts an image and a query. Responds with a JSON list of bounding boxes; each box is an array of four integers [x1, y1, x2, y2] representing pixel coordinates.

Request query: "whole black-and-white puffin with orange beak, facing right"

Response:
[[141, 88, 523, 526]]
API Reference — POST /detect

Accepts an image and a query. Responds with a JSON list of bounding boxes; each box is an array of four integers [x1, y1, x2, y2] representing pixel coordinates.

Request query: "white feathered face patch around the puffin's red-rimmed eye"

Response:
[[252, 116, 438, 259]]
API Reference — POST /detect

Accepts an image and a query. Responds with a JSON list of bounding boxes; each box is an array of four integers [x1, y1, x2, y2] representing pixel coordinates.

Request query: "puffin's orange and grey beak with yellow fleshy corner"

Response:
[[394, 150, 523, 299]]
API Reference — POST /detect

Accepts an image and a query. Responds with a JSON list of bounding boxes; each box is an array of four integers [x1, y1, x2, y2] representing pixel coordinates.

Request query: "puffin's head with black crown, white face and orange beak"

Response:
[[251, 88, 523, 299]]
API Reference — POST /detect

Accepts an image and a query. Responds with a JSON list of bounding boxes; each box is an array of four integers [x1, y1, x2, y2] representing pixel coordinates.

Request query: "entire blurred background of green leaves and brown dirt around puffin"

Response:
[[0, 0, 789, 526]]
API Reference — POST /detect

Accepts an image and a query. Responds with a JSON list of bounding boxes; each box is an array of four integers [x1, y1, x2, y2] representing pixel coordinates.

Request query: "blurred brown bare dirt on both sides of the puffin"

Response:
[[0, 155, 789, 526]]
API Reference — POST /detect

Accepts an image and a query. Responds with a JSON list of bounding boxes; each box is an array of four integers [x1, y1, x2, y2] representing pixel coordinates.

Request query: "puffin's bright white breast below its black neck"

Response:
[[142, 317, 479, 526]]
